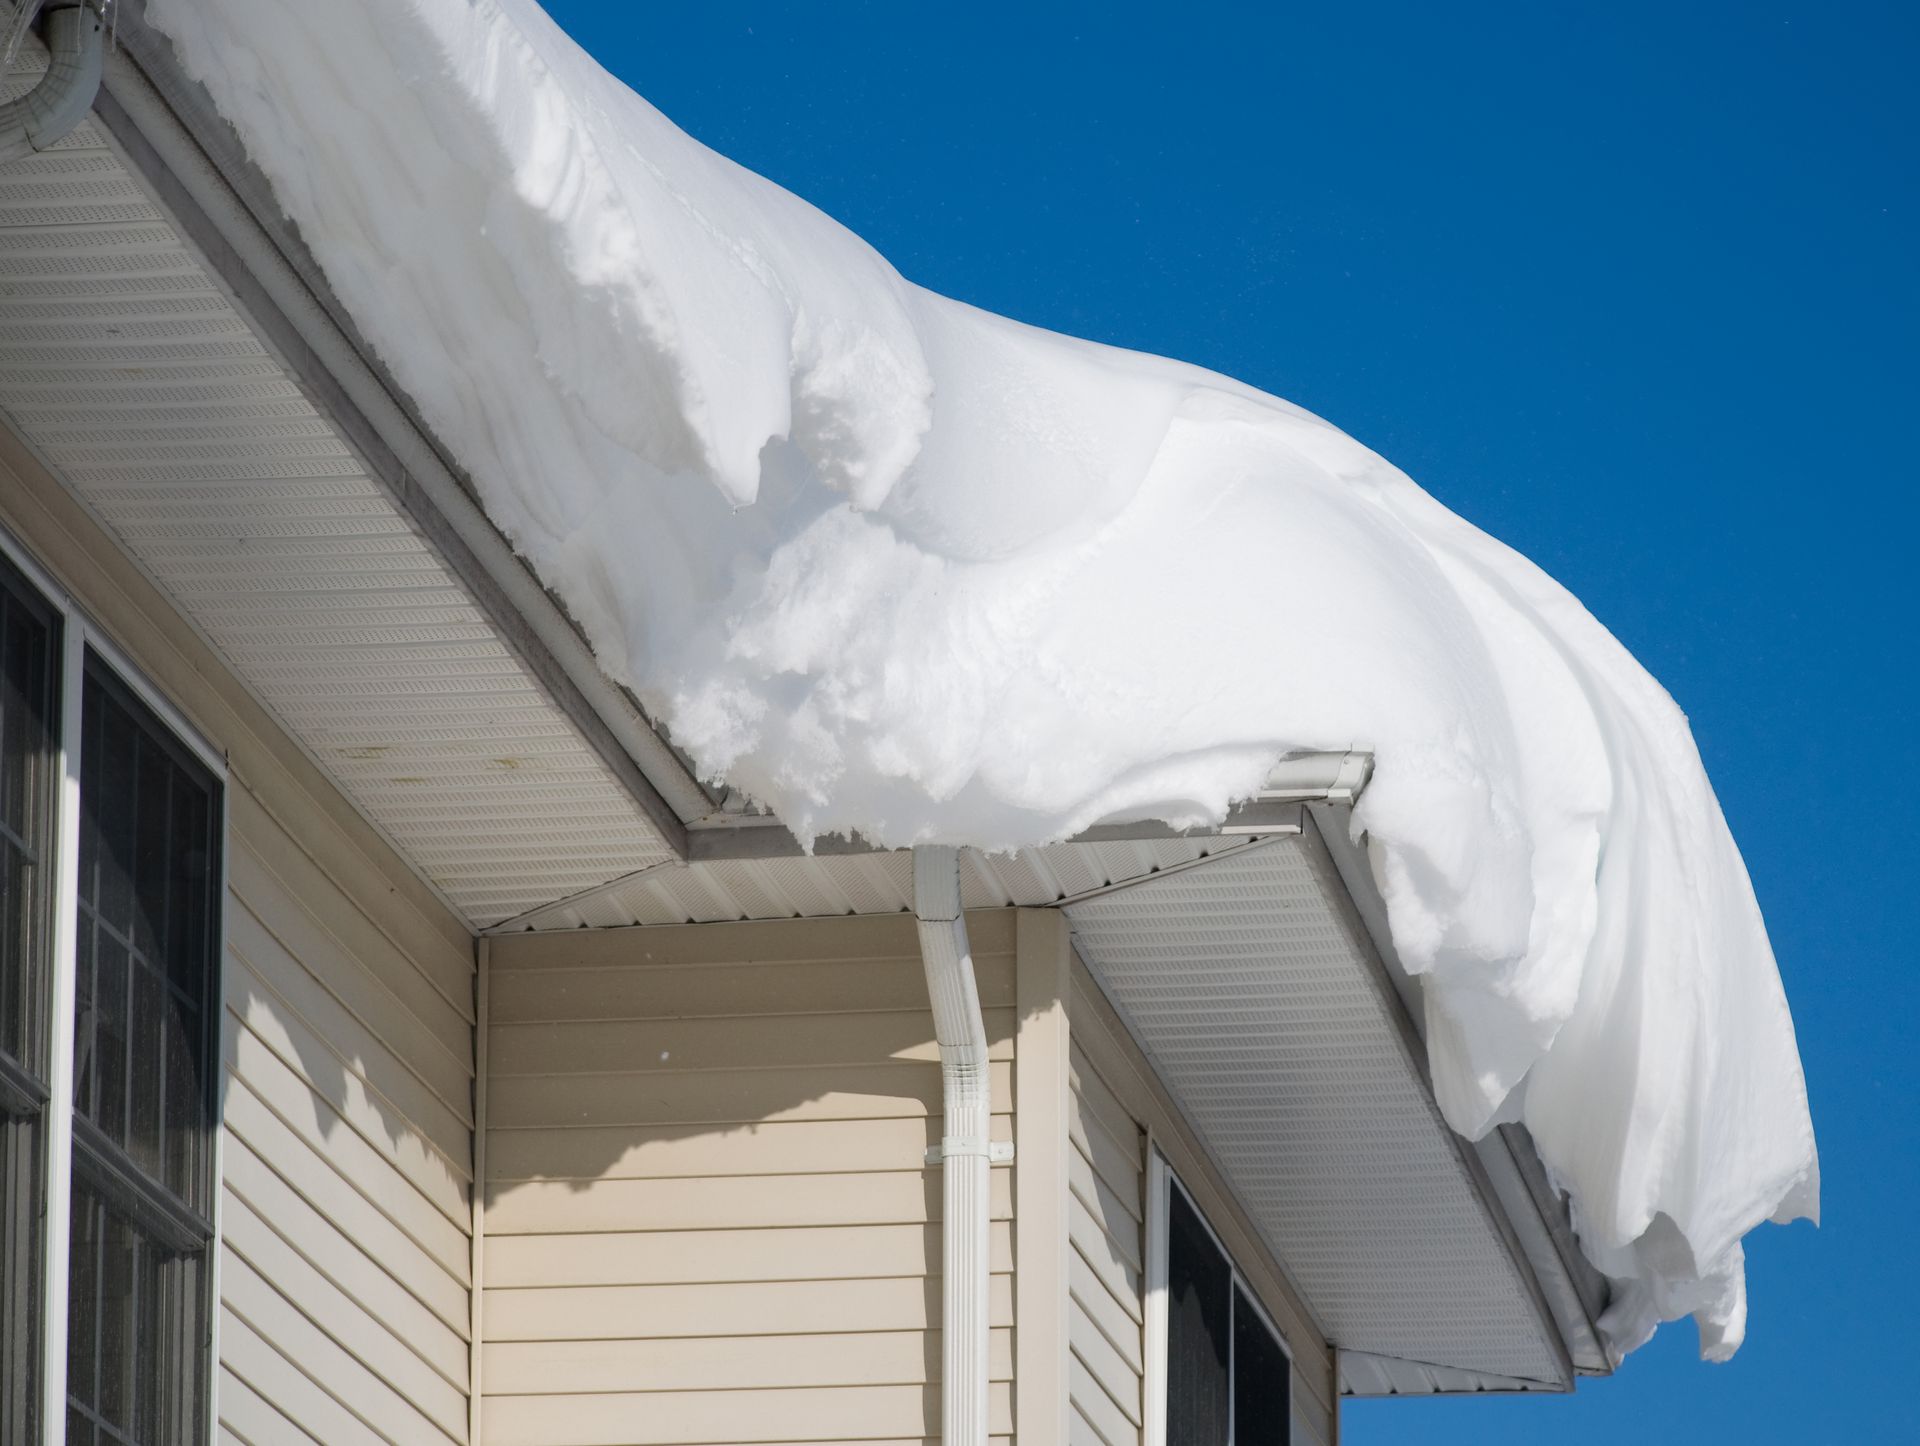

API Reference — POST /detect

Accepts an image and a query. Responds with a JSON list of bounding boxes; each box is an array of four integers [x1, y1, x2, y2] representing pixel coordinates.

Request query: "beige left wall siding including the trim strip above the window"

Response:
[[0, 428, 474, 1446]]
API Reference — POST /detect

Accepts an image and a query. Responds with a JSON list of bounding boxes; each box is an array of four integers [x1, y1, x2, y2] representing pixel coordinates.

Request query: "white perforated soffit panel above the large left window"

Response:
[[0, 61, 672, 926]]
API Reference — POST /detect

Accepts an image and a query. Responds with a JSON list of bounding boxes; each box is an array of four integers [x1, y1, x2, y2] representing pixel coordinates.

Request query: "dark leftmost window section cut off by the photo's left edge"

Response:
[[0, 557, 60, 1446]]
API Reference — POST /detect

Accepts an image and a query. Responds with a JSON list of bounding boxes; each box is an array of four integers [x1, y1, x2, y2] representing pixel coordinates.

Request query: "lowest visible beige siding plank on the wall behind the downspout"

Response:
[[486, 1385, 1014, 1446]]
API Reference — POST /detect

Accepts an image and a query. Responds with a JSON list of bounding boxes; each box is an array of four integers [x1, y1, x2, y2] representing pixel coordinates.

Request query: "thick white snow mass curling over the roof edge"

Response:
[[148, 0, 1818, 1356]]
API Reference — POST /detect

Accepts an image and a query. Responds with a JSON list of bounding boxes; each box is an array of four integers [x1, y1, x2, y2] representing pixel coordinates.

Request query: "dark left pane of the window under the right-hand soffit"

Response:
[[1167, 1189, 1233, 1446]]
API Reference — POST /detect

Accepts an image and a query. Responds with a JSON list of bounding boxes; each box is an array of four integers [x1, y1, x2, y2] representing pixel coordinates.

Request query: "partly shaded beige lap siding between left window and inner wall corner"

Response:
[[221, 787, 472, 1446]]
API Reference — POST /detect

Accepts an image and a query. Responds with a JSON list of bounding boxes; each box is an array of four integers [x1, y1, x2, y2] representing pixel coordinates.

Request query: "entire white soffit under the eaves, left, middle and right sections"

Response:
[[0, 31, 1605, 1394]]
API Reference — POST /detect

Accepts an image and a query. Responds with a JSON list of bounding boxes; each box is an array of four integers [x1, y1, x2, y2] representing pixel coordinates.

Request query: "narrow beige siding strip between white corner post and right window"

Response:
[[1068, 1047, 1146, 1446]]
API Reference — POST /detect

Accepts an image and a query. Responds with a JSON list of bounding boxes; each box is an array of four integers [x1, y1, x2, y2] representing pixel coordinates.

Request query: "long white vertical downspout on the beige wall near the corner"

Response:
[[914, 845, 1012, 1446]]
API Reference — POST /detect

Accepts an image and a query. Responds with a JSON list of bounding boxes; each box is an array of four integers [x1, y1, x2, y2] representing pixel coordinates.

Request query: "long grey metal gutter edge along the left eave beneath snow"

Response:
[[98, 4, 714, 833]]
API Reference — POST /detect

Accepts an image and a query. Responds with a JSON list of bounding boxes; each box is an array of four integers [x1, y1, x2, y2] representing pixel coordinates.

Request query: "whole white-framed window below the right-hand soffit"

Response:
[[1148, 1154, 1292, 1446]]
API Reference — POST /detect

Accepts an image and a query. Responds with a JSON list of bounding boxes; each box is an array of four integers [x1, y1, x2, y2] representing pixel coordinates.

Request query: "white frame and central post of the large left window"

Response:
[[0, 528, 232, 1446]]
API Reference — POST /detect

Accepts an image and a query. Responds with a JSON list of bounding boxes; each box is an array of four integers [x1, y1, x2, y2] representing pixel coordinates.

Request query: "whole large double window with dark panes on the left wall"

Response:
[[0, 537, 223, 1446]]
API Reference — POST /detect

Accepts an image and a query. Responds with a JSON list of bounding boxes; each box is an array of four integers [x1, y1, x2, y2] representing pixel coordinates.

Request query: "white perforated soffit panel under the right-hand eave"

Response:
[[1068, 837, 1565, 1383]]
